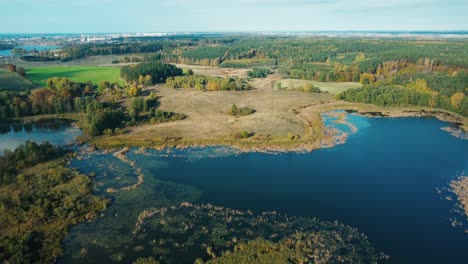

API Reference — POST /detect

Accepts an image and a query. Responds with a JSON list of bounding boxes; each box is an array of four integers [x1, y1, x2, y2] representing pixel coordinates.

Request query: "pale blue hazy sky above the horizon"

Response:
[[0, 0, 468, 33]]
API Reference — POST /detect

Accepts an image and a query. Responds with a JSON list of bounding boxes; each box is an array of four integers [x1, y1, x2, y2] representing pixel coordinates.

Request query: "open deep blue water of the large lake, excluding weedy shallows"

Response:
[[154, 118, 468, 263]]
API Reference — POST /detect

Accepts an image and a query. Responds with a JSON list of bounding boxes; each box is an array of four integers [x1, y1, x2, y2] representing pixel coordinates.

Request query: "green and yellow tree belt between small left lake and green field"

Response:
[[0, 73, 185, 136]]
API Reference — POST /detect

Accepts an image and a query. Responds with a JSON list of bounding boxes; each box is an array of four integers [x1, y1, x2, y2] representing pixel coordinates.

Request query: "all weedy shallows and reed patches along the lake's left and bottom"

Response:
[[60, 145, 381, 263]]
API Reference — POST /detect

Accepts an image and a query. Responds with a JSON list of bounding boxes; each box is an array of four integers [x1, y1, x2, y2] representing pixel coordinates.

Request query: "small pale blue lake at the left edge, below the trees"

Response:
[[0, 119, 81, 156]]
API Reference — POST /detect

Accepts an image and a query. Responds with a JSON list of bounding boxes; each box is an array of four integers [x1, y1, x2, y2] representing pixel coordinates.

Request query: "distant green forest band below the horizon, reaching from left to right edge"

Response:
[[63, 36, 468, 69]]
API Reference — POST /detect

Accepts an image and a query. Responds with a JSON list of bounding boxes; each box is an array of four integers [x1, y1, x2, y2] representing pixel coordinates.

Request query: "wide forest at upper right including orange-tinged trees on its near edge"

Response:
[[163, 37, 468, 85]]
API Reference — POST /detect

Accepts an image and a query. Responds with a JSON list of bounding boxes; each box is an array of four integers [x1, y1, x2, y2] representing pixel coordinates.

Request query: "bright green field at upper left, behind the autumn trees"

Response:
[[26, 66, 122, 86]]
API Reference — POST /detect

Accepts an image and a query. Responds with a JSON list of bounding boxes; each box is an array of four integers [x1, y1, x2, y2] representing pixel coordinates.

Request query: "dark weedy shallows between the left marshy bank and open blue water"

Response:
[[61, 151, 200, 263]]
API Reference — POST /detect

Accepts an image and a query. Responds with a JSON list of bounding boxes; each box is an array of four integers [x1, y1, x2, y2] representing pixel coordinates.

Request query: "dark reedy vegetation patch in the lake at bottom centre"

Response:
[[129, 202, 386, 263]]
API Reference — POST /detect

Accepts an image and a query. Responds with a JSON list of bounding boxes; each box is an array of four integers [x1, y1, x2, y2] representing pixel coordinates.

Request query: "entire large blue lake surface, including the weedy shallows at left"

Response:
[[61, 115, 468, 263]]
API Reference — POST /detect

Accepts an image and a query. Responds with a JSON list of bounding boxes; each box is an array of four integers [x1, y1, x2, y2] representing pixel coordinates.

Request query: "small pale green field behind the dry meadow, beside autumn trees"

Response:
[[275, 79, 362, 94]]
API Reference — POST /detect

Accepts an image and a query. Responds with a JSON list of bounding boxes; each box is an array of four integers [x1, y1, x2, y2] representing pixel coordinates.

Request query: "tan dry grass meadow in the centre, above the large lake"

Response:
[[131, 76, 333, 139]]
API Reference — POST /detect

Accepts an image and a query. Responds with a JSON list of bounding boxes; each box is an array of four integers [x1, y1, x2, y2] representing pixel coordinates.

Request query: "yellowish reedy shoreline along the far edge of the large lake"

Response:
[[88, 101, 468, 153]]
